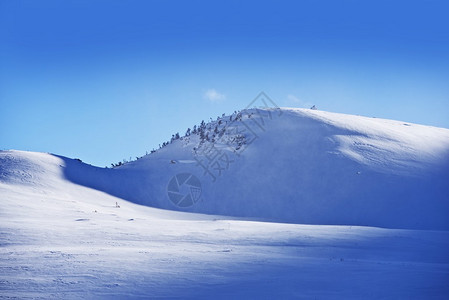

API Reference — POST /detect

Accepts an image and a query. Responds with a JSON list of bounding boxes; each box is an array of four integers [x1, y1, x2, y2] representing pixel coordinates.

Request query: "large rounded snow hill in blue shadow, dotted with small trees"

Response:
[[32, 109, 449, 230]]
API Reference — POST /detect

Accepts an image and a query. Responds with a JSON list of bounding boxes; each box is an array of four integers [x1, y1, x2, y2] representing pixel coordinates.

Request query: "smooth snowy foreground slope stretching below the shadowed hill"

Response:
[[0, 149, 449, 299]]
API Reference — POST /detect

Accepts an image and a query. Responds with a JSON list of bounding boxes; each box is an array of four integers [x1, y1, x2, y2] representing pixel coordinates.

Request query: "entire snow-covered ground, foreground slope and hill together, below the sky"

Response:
[[0, 109, 449, 299]]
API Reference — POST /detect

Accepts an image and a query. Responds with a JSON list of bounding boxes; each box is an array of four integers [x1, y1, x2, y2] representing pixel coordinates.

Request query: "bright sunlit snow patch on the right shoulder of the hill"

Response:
[[300, 111, 449, 175]]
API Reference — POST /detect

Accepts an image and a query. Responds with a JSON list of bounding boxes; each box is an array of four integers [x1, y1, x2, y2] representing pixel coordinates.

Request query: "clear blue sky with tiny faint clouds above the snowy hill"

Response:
[[0, 0, 449, 166]]
